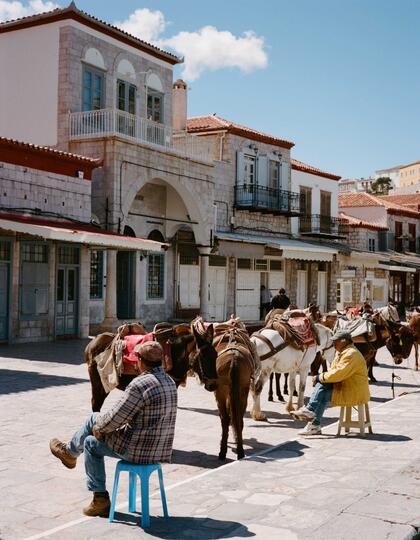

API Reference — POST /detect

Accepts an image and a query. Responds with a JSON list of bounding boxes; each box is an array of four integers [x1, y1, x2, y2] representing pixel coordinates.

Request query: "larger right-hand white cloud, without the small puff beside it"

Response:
[[160, 26, 268, 81]]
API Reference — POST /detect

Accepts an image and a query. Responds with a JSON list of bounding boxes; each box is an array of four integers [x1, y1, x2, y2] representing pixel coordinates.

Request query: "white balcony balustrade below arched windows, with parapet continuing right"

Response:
[[69, 109, 213, 161]]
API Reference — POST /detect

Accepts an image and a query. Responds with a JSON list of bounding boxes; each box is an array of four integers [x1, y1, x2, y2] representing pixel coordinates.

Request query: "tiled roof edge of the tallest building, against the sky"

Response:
[[0, 2, 183, 65]]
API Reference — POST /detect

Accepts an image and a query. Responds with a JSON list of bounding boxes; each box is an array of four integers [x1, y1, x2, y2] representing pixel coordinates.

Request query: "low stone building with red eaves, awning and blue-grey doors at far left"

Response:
[[0, 137, 161, 343]]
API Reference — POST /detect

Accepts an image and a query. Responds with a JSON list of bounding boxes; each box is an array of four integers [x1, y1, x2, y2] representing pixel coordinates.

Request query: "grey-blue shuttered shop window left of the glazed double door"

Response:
[[20, 242, 50, 319]]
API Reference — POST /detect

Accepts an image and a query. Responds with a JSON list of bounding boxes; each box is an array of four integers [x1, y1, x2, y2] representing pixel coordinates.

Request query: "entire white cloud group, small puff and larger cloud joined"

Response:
[[114, 8, 268, 81]]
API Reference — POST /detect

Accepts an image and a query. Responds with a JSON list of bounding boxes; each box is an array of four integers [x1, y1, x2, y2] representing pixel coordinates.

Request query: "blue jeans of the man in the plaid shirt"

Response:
[[67, 413, 124, 492]]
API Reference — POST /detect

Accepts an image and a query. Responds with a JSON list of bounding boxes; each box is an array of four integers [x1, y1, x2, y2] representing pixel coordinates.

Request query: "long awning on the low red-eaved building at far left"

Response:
[[0, 216, 166, 251]]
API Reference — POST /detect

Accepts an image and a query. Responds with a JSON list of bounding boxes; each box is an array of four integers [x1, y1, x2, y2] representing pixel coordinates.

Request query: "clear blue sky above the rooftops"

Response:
[[3, 0, 420, 177]]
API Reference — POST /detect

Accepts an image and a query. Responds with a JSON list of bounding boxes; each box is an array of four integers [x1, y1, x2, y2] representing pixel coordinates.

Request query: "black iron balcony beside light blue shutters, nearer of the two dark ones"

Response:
[[235, 184, 305, 216]]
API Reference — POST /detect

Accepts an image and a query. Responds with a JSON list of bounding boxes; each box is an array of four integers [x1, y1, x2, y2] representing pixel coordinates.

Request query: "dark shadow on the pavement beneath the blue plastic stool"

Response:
[[110, 512, 255, 540]]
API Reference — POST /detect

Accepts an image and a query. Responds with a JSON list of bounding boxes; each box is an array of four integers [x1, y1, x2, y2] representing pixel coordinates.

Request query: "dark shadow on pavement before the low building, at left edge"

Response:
[[0, 339, 89, 365]]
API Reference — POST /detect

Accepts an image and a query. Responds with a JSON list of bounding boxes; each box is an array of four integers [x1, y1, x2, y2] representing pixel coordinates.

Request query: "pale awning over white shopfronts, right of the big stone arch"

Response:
[[215, 232, 338, 262]]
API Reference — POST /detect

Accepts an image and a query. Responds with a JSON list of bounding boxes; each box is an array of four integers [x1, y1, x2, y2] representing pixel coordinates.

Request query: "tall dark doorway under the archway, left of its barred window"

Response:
[[117, 225, 136, 319]]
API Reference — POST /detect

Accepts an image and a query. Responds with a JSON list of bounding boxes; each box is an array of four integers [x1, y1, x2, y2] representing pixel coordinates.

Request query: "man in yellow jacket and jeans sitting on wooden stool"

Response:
[[292, 331, 370, 436]]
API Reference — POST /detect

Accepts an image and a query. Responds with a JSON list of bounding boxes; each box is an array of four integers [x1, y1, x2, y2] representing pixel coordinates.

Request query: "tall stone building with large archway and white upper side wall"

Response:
[[0, 3, 214, 327]]
